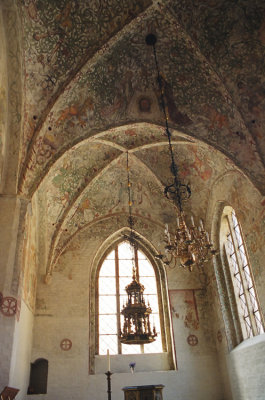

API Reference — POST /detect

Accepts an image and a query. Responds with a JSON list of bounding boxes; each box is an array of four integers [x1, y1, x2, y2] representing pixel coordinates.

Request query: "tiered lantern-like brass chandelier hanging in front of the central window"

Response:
[[119, 152, 157, 344]]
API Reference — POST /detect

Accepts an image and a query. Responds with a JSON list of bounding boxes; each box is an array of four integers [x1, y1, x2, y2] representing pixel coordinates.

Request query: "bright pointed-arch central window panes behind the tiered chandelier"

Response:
[[97, 242, 163, 355]]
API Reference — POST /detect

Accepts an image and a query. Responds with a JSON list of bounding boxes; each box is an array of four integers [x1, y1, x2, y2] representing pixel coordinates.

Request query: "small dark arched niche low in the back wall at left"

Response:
[[28, 358, 48, 394]]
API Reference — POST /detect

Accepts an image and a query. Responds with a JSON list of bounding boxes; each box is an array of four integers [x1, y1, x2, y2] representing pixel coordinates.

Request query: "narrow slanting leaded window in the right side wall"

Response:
[[221, 207, 264, 339]]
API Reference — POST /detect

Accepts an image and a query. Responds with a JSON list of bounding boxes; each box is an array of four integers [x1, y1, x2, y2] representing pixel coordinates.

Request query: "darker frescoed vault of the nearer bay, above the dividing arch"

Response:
[[19, 0, 264, 195]]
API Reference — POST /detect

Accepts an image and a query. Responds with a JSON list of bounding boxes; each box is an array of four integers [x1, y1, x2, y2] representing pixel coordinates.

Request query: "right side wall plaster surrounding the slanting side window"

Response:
[[207, 171, 265, 400]]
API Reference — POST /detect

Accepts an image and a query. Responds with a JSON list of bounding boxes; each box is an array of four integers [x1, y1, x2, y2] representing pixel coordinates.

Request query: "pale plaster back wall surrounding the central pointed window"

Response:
[[27, 216, 223, 400]]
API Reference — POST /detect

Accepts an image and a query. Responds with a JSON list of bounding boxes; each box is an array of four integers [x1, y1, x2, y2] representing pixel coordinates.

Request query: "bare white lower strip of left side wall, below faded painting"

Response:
[[9, 300, 33, 400]]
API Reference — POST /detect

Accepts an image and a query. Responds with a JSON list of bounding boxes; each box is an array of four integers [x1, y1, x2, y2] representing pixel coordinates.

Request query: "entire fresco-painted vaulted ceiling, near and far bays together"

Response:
[[6, 0, 265, 278]]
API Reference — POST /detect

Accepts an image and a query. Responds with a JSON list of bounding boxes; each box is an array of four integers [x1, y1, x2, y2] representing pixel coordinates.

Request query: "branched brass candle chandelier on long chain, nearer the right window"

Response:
[[145, 34, 216, 271]]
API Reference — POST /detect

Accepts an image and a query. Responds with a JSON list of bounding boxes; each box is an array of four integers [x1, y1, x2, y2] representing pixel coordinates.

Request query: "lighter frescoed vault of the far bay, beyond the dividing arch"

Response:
[[37, 132, 236, 276]]
